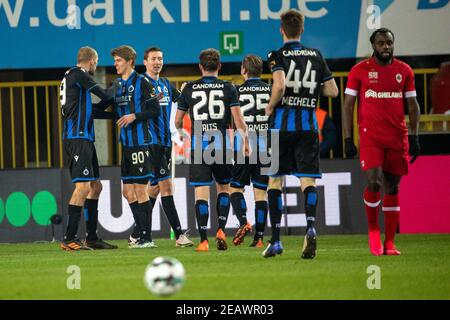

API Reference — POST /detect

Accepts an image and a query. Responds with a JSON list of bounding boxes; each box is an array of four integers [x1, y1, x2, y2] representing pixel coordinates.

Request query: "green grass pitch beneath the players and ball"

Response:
[[0, 234, 450, 300]]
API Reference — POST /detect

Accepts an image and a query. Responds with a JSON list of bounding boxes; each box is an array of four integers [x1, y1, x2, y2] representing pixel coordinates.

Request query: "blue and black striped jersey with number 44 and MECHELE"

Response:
[[268, 41, 333, 132]]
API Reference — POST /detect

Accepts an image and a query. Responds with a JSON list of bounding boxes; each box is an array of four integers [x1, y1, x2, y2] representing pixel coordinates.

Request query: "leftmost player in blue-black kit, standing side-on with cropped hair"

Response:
[[60, 47, 117, 251]]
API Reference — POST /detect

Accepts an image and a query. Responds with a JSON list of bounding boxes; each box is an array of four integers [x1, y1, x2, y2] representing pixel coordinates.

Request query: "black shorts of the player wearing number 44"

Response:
[[270, 131, 322, 178]]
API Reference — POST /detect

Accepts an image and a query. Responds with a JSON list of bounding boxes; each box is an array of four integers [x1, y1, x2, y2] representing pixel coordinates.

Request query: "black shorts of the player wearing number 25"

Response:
[[230, 158, 269, 190]]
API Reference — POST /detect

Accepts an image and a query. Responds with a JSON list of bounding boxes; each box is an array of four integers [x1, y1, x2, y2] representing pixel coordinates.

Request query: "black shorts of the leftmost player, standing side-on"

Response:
[[64, 139, 100, 182]]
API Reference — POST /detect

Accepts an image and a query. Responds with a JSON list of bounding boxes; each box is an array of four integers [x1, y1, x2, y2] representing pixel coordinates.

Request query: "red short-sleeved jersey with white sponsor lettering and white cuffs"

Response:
[[345, 58, 417, 147]]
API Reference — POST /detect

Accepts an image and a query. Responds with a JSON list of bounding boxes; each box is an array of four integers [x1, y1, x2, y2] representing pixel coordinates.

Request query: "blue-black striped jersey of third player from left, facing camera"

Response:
[[145, 74, 181, 147]]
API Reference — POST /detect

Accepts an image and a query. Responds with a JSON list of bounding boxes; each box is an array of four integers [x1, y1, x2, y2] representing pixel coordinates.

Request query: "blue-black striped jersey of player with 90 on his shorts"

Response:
[[113, 71, 160, 147]]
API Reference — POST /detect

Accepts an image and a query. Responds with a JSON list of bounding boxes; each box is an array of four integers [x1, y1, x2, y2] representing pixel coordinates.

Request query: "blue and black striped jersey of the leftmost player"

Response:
[[60, 67, 111, 141]]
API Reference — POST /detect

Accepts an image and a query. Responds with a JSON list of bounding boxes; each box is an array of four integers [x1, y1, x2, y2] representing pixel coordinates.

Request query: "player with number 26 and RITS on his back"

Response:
[[175, 49, 249, 251]]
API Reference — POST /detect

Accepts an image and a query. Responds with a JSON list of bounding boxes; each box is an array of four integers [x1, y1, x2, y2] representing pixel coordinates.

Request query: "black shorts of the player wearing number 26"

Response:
[[189, 164, 232, 187]]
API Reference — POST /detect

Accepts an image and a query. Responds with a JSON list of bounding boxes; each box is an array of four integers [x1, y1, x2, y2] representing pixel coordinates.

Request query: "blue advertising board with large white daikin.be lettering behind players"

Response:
[[0, 0, 361, 69]]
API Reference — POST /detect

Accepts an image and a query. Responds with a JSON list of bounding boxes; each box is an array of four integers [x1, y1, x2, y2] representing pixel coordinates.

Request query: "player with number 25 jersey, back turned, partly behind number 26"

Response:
[[230, 54, 271, 248]]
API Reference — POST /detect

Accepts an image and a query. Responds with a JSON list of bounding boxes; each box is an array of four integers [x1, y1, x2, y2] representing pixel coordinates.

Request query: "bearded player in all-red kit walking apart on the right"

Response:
[[342, 28, 420, 256]]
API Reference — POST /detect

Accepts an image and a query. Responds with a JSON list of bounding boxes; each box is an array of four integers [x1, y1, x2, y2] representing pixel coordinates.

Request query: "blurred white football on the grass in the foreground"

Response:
[[144, 257, 185, 296]]
